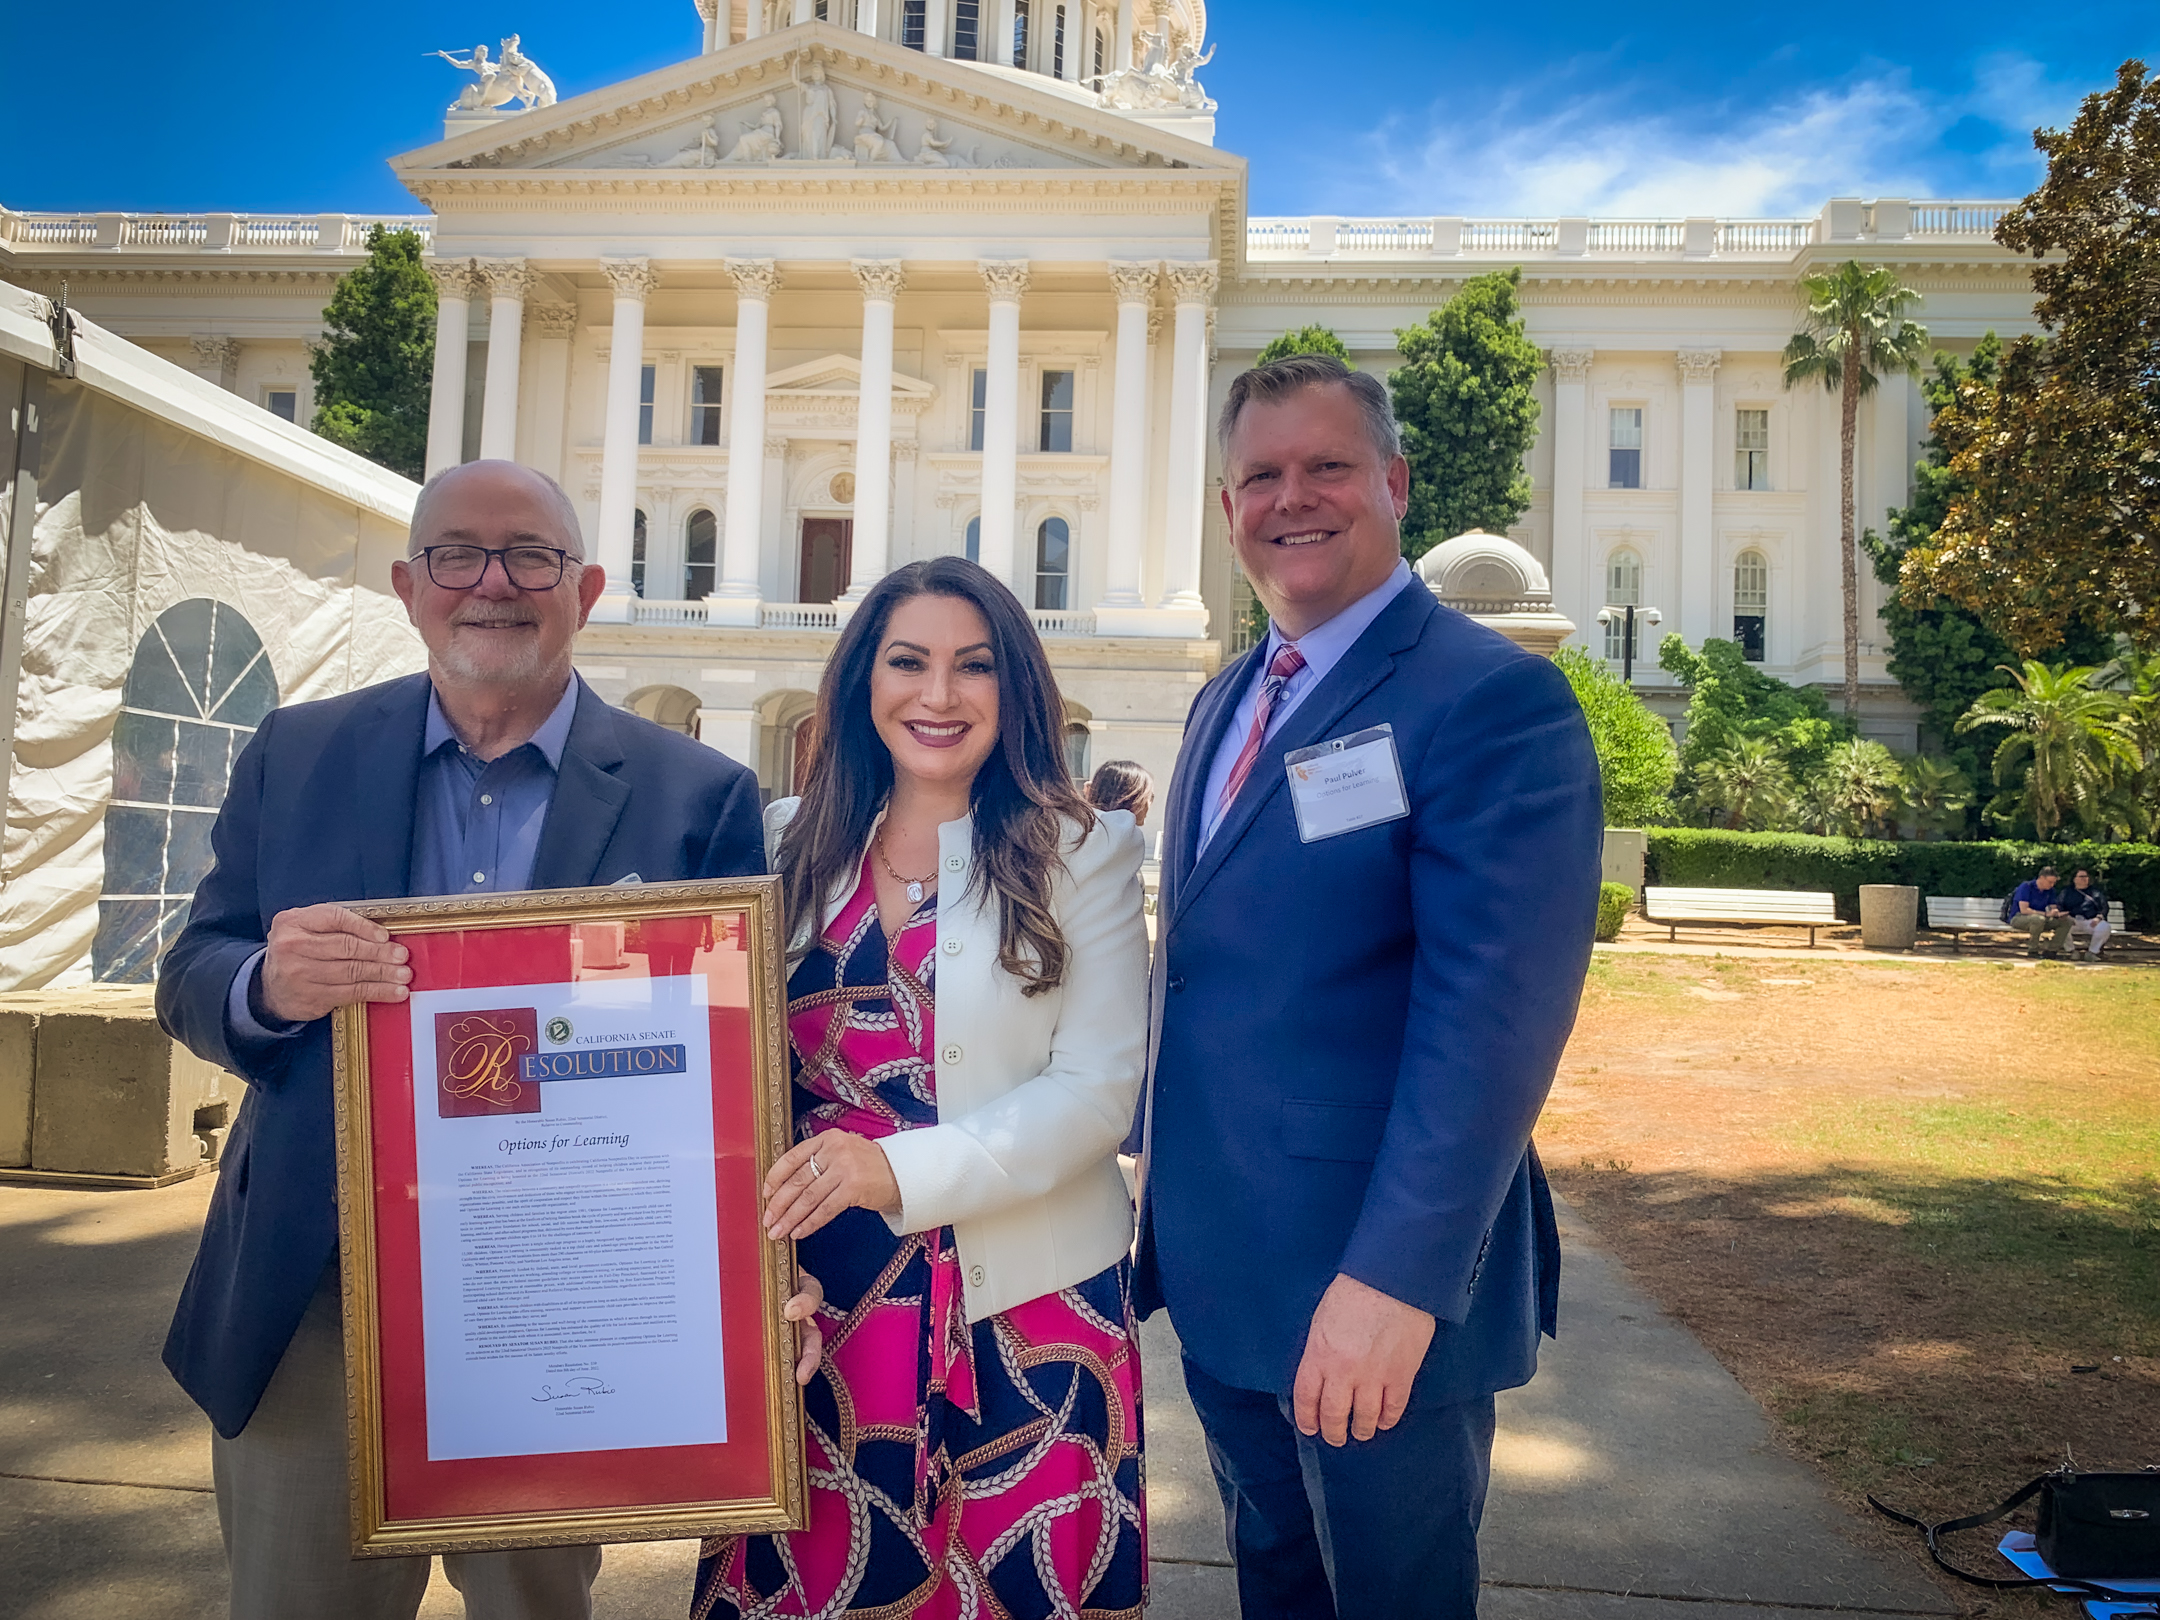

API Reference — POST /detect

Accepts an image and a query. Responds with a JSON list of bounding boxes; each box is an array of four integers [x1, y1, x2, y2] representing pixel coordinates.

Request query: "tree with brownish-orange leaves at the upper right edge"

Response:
[[1903, 60, 2160, 659]]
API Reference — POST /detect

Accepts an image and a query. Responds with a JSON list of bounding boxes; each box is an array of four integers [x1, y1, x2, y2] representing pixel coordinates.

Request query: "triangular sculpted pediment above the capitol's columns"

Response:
[[391, 22, 1242, 185]]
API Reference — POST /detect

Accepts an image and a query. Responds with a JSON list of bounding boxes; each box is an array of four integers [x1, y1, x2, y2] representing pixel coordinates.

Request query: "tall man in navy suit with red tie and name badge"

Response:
[[1134, 356, 1603, 1620]]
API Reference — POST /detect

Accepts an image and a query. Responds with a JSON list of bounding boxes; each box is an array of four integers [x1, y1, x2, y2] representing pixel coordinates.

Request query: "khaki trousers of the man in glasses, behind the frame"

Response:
[[210, 1266, 600, 1620]]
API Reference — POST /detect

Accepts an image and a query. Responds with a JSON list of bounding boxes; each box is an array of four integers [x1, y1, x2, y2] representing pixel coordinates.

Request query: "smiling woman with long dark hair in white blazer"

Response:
[[693, 557, 1147, 1620]]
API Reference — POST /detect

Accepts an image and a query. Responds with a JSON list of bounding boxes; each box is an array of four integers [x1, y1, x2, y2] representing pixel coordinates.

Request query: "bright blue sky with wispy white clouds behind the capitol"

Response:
[[0, 0, 2160, 218]]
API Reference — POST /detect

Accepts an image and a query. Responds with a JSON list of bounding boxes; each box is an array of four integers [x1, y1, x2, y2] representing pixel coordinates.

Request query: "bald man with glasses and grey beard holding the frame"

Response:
[[158, 462, 764, 1620]]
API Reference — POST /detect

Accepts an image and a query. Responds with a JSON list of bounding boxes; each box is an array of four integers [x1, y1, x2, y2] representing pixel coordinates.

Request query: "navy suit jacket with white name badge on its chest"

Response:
[[1134, 581, 1605, 1400]]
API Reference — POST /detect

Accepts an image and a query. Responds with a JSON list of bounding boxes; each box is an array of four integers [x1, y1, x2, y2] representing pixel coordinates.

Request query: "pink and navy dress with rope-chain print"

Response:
[[691, 860, 1147, 1620]]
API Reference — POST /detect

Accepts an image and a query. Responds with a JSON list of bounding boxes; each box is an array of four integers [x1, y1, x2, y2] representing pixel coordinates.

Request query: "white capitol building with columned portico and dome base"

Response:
[[0, 0, 2035, 984]]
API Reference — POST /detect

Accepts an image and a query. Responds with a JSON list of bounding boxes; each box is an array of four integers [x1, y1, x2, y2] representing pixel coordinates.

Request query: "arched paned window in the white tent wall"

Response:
[[91, 598, 279, 985]]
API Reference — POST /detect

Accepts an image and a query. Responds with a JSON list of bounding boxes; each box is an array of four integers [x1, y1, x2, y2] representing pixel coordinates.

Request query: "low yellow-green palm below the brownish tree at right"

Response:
[[1957, 659, 2136, 840]]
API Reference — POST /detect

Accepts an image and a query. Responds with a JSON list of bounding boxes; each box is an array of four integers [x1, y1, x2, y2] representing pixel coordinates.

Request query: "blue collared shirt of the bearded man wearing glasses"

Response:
[[225, 674, 583, 1041]]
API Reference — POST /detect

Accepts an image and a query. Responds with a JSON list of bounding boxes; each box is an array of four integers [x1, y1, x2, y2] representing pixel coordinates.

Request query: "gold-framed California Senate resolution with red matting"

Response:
[[333, 877, 804, 1555]]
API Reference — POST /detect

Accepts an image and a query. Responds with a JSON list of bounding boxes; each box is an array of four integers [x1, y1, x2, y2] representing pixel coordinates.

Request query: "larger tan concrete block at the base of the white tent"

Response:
[[30, 989, 240, 1177]]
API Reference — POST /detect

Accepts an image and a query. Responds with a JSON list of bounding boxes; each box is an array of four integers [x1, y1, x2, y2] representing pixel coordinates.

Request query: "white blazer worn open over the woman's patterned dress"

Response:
[[765, 799, 1147, 1322]]
